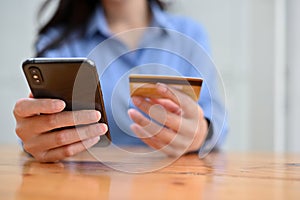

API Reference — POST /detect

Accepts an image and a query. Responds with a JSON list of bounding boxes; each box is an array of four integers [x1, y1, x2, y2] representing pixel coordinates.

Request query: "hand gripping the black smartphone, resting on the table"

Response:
[[14, 95, 108, 162]]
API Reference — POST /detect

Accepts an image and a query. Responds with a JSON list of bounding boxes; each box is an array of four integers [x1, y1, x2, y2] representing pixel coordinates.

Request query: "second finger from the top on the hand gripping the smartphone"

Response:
[[20, 110, 101, 135]]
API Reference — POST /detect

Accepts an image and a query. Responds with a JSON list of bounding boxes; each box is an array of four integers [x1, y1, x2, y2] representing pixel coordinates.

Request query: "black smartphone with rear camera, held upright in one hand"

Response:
[[22, 58, 111, 146]]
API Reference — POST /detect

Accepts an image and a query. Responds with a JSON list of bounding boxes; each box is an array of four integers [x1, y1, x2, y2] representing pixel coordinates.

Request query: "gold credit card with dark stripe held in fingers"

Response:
[[129, 74, 203, 101]]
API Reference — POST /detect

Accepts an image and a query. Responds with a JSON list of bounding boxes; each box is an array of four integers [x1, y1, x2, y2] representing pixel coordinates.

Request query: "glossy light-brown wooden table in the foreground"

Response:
[[0, 146, 300, 200]]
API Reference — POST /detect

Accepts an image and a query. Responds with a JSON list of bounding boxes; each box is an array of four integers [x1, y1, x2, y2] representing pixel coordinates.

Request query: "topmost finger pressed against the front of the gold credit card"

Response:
[[156, 83, 197, 114]]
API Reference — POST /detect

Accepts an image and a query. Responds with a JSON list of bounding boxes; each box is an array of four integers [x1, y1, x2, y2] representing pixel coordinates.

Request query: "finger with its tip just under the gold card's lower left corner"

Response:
[[132, 96, 184, 132]]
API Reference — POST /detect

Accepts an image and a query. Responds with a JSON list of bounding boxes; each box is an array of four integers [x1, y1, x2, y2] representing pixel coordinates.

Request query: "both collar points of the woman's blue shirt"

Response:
[[86, 0, 174, 37]]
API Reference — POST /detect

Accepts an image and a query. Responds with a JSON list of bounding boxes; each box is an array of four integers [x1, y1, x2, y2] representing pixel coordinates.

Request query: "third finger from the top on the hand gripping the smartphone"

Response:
[[24, 123, 108, 152]]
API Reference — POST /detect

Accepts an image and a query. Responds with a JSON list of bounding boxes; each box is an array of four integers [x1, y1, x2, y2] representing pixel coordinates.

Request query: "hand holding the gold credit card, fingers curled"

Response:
[[128, 83, 208, 156]]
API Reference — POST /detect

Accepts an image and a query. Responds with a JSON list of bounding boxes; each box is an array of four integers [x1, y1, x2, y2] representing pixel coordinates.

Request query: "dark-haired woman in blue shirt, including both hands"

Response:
[[14, 0, 226, 162]]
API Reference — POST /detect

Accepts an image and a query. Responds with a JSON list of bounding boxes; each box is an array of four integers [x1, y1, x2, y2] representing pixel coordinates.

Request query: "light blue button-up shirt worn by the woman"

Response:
[[36, 2, 227, 155]]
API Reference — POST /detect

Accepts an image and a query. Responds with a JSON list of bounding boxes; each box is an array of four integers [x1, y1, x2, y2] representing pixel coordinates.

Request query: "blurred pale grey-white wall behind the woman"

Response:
[[0, 0, 300, 152]]
